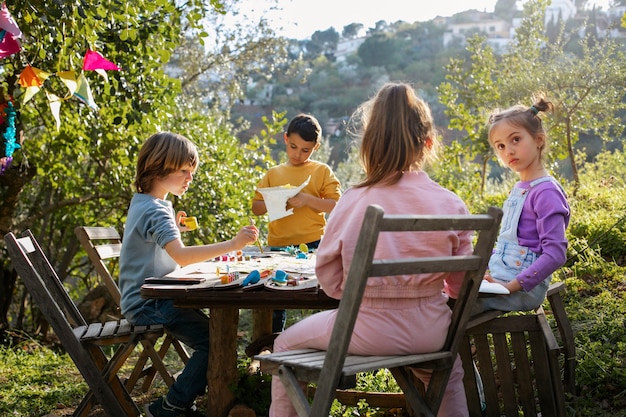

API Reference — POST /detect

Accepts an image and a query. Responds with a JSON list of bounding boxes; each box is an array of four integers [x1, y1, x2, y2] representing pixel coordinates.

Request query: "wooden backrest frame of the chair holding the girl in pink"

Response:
[[311, 205, 502, 415]]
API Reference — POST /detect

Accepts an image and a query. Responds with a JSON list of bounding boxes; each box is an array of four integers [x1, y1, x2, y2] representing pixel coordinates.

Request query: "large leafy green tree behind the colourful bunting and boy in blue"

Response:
[[0, 0, 282, 338]]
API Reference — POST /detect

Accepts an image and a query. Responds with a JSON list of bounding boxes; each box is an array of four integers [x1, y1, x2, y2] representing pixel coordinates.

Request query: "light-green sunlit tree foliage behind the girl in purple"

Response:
[[440, 0, 626, 195]]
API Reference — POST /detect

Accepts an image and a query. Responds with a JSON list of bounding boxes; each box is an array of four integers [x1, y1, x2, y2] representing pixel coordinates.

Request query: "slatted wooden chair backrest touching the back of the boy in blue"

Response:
[[74, 226, 122, 306]]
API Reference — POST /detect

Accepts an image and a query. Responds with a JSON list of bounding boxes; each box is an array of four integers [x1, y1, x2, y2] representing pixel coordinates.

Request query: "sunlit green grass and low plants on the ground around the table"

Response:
[[0, 152, 626, 417]]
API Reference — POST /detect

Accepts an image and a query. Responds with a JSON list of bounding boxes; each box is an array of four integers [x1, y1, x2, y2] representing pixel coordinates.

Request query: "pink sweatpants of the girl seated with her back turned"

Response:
[[270, 295, 469, 417]]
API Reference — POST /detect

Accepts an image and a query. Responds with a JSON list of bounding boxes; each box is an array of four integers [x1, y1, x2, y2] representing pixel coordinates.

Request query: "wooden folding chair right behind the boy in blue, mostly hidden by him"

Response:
[[74, 226, 189, 392]]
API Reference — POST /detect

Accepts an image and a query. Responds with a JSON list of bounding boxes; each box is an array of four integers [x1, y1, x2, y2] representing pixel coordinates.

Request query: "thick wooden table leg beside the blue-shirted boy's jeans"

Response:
[[207, 308, 239, 417]]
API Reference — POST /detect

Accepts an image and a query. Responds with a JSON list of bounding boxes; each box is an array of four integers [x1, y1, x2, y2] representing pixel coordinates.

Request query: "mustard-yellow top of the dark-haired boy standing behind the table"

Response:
[[253, 160, 341, 246]]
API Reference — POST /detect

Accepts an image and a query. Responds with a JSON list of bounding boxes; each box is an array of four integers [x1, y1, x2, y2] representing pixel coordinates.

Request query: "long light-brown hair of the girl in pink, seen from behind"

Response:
[[357, 83, 439, 187]]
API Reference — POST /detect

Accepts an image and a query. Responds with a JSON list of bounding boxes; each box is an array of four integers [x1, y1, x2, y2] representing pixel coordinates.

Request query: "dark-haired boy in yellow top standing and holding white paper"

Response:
[[252, 114, 341, 331]]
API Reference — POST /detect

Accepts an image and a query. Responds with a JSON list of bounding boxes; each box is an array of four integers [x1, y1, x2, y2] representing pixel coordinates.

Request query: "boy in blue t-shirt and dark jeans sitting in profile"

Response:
[[120, 132, 258, 417]]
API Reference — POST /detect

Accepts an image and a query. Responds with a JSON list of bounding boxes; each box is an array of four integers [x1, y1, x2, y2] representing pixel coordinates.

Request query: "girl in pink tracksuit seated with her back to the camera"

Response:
[[270, 83, 472, 417]]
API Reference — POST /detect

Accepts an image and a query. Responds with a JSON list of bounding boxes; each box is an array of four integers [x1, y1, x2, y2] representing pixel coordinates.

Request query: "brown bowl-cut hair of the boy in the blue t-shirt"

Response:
[[135, 132, 199, 193]]
